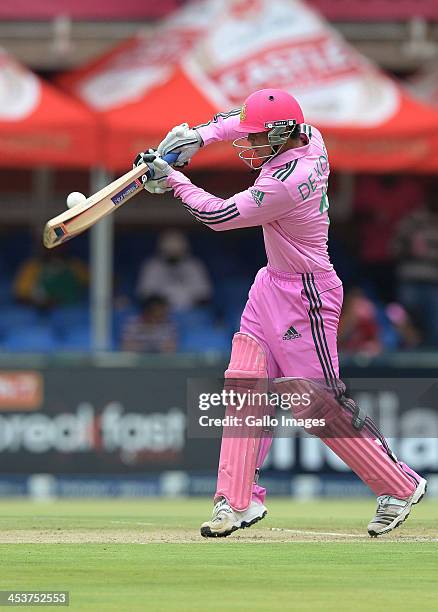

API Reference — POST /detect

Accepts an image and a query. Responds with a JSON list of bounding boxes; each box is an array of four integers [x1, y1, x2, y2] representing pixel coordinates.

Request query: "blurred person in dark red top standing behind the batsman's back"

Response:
[[355, 174, 423, 302]]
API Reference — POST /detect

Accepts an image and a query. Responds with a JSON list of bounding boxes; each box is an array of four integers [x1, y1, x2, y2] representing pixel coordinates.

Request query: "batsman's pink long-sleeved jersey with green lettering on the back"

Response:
[[168, 111, 333, 273]]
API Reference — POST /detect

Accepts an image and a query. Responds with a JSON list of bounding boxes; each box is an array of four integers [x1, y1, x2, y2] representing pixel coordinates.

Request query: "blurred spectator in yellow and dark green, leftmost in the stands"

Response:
[[14, 251, 88, 309]]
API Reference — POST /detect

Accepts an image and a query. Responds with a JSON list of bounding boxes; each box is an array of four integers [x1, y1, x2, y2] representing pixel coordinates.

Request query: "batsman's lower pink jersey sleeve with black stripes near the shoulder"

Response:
[[168, 170, 293, 231]]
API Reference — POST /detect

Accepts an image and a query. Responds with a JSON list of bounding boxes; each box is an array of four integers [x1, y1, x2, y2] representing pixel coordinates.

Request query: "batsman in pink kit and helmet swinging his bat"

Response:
[[134, 89, 427, 537]]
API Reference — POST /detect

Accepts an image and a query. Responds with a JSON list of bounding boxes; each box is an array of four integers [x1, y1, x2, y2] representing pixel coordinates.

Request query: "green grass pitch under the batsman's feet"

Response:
[[0, 499, 438, 612]]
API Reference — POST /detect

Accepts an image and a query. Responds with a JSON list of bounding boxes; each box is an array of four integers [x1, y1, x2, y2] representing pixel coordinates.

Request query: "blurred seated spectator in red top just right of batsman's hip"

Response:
[[338, 287, 383, 356]]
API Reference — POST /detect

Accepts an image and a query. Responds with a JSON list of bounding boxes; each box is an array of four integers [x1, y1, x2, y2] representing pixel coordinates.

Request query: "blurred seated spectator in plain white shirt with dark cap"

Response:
[[137, 230, 212, 310]]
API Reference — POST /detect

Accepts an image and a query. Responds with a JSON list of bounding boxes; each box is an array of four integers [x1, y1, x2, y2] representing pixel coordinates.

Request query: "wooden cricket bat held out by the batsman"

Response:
[[43, 153, 178, 249]]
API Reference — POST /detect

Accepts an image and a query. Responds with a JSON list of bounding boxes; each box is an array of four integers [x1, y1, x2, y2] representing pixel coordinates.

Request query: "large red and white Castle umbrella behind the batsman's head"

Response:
[[59, 0, 438, 172]]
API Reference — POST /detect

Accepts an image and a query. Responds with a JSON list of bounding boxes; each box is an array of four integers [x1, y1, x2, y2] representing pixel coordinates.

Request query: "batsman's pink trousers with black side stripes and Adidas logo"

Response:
[[240, 268, 343, 383]]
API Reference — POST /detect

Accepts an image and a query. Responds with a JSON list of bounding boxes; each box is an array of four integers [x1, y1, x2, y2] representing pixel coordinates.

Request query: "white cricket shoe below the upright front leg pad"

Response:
[[201, 497, 268, 538]]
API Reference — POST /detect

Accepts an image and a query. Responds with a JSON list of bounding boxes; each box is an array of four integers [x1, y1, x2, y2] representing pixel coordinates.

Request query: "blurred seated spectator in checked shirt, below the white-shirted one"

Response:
[[121, 296, 177, 353]]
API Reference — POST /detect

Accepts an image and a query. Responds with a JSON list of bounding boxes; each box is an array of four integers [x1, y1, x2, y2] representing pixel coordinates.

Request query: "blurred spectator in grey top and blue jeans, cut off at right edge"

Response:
[[393, 188, 438, 347]]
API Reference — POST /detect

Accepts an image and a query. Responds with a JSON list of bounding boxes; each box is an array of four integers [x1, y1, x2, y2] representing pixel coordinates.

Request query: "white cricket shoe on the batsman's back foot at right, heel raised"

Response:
[[368, 478, 427, 538]]
